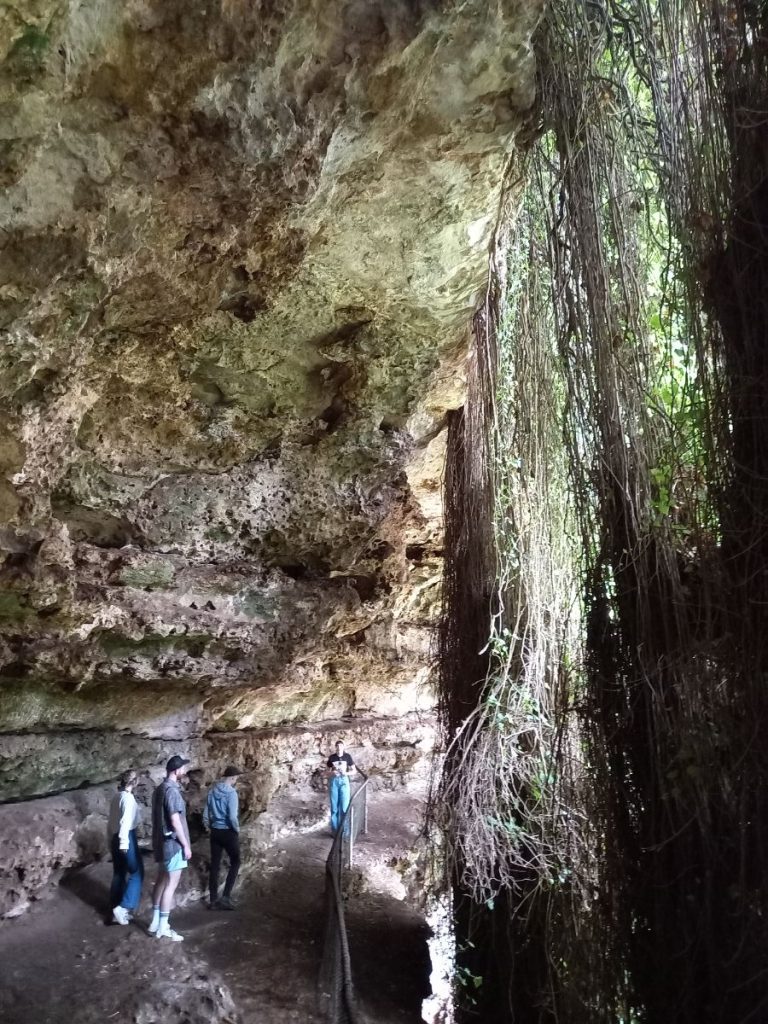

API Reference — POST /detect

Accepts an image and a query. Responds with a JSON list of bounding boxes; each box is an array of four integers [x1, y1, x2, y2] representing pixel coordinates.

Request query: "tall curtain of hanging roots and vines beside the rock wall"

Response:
[[440, 0, 768, 1024]]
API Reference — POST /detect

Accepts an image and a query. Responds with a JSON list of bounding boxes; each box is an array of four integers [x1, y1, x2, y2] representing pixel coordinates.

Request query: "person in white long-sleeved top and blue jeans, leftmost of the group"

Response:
[[106, 769, 144, 925]]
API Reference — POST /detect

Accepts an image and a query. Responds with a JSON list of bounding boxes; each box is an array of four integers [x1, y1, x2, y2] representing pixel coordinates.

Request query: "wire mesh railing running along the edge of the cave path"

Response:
[[319, 769, 369, 1024]]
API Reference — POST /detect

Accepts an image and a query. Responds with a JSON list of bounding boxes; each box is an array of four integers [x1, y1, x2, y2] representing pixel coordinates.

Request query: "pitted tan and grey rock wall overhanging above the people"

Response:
[[0, 0, 541, 914]]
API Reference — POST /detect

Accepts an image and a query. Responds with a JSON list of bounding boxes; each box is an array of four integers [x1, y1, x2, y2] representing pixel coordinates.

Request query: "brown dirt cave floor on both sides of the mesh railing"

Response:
[[0, 794, 429, 1024]]
